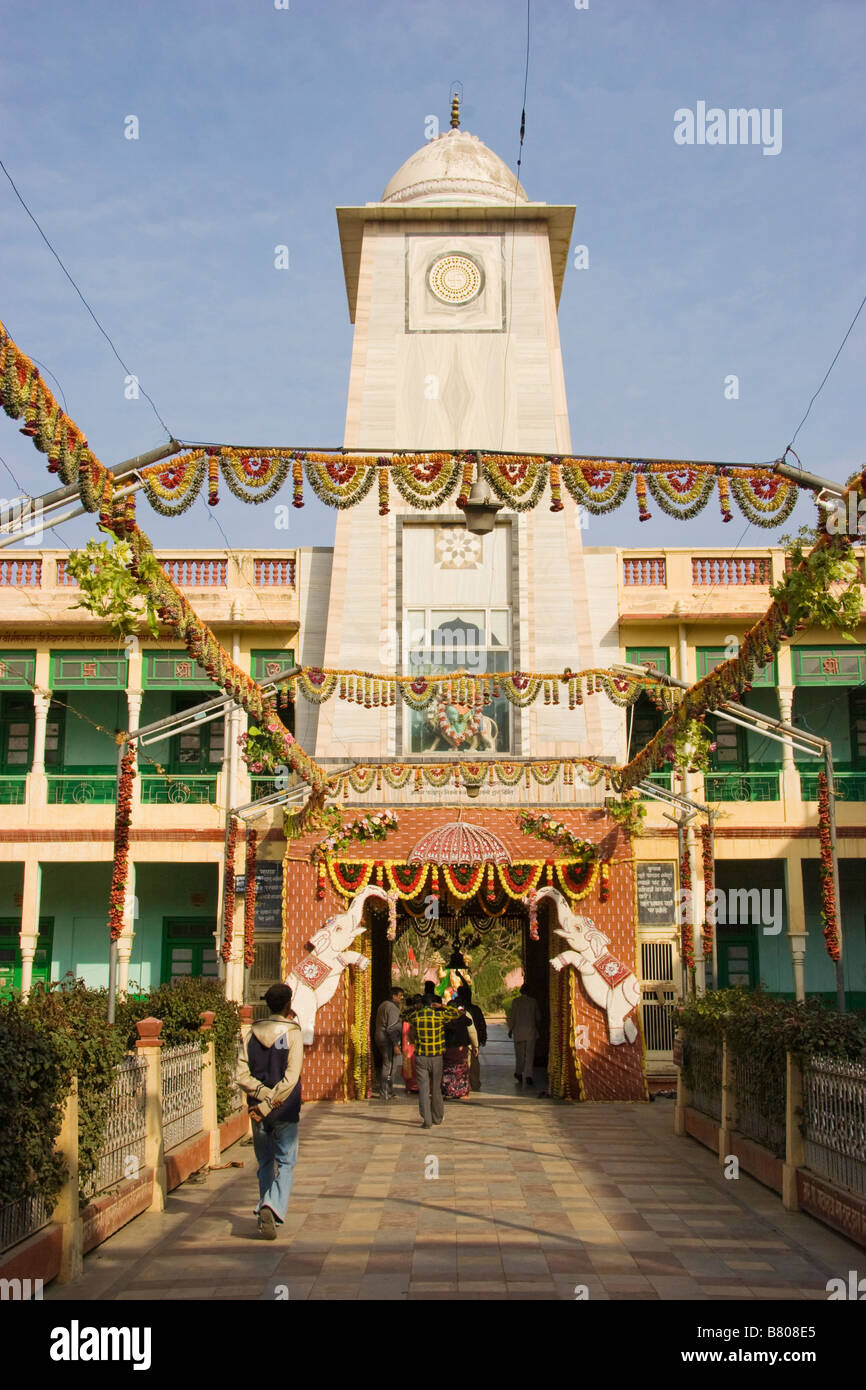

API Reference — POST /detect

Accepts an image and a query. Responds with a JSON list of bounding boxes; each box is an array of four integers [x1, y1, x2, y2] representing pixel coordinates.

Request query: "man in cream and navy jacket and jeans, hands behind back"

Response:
[[236, 984, 303, 1240]]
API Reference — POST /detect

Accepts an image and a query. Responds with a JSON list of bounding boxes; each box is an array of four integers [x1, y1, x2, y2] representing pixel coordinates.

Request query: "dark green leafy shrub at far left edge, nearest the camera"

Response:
[[0, 998, 71, 1204]]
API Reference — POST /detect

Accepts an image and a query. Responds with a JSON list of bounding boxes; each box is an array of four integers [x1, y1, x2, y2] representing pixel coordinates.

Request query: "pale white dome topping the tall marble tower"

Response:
[[382, 129, 528, 204]]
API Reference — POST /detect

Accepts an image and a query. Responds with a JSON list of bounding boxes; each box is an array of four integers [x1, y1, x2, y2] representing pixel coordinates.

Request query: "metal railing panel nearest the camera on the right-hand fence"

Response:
[[803, 1056, 866, 1197]]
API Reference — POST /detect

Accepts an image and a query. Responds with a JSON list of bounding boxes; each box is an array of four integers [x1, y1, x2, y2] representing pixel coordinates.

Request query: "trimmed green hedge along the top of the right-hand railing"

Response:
[[676, 990, 866, 1063]]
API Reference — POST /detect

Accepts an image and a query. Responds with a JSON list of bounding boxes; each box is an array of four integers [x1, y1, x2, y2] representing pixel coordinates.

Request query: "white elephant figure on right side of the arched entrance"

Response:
[[538, 888, 641, 1044]]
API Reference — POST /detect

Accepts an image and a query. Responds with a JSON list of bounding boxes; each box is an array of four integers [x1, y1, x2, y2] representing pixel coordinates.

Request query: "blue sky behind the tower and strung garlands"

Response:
[[0, 0, 866, 546]]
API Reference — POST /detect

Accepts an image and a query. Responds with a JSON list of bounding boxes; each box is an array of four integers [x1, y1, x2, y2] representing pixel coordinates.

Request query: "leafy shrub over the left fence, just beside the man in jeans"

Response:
[[117, 976, 240, 1120]]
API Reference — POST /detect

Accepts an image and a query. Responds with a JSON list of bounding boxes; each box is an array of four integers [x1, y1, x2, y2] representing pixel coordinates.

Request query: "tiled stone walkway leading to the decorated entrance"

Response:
[[46, 1026, 862, 1301]]
